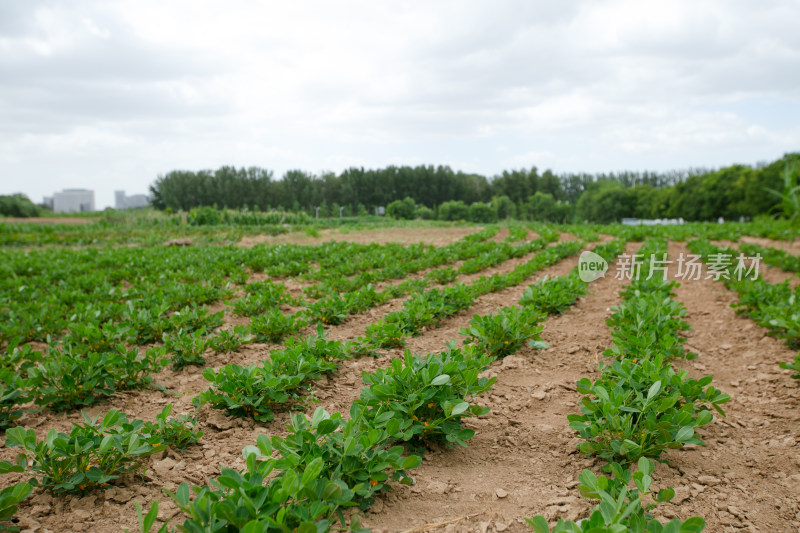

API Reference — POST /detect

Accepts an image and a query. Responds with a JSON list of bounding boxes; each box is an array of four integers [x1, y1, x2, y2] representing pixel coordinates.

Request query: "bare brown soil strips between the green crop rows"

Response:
[[0, 233, 800, 533]]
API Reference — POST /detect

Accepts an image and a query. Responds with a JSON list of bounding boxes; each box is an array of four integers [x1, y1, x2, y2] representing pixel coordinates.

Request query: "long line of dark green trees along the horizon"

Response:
[[142, 154, 797, 222]]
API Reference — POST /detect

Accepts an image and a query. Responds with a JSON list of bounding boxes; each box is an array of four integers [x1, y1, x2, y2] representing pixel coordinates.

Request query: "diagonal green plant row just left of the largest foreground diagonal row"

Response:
[[195, 241, 582, 421]]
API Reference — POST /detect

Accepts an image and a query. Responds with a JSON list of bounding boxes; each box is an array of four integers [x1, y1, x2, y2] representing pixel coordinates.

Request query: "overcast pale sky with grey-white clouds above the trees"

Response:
[[0, 0, 800, 208]]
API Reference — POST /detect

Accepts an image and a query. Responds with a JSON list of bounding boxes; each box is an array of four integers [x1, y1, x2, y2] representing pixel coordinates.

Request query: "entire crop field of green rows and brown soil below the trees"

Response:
[[0, 218, 800, 533]]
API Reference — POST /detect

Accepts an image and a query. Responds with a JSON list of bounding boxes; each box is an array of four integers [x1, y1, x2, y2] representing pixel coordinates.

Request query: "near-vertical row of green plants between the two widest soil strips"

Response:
[[528, 240, 730, 533]]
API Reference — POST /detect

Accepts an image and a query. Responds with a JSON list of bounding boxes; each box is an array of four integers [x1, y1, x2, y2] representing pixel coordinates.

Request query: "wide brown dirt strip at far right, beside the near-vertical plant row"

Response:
[[653, 243, 800, 533]]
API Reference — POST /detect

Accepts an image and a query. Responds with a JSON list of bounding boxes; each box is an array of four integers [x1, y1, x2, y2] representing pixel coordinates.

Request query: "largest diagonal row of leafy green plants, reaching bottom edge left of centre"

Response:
[[141, 284, 564, 532]]
